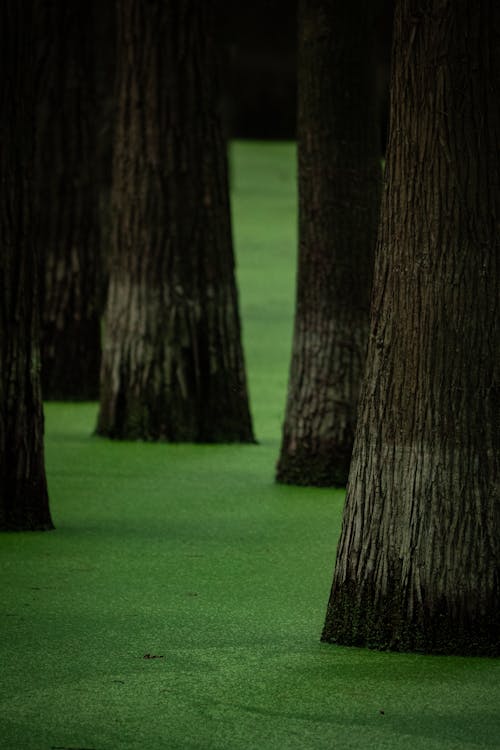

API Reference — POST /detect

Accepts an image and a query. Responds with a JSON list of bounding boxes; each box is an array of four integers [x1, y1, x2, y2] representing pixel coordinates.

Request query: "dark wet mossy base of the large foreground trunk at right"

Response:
[[321, 584, 500, 657]]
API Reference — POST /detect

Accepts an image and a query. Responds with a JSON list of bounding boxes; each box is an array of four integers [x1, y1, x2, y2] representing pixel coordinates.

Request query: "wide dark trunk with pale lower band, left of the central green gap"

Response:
[[97, 0, 253, 442]]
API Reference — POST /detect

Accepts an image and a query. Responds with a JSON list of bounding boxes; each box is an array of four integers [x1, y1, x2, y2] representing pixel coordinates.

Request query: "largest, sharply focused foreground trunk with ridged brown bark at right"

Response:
[[323, 0, 500, 655]]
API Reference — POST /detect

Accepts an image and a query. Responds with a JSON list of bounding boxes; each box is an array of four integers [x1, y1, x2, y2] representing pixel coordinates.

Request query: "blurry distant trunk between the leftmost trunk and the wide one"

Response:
[[36, 0, 103, 400]]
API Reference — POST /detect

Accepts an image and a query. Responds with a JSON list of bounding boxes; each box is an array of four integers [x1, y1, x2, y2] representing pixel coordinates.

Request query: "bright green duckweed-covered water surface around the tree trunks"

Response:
[[0, 142, 500, 750]]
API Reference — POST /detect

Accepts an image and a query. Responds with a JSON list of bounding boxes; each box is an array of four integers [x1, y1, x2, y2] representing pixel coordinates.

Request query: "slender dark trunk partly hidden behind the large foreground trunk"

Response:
[[277, 0, 381, 485]]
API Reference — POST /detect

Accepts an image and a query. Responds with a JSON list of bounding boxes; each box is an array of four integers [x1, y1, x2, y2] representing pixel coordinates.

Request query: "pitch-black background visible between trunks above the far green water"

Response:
[[216, 0, 394, 151]]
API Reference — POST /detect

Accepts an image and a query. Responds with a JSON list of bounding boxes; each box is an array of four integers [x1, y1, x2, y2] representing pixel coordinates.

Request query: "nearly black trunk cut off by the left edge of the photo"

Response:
[[0, 0, 52, 530]]
